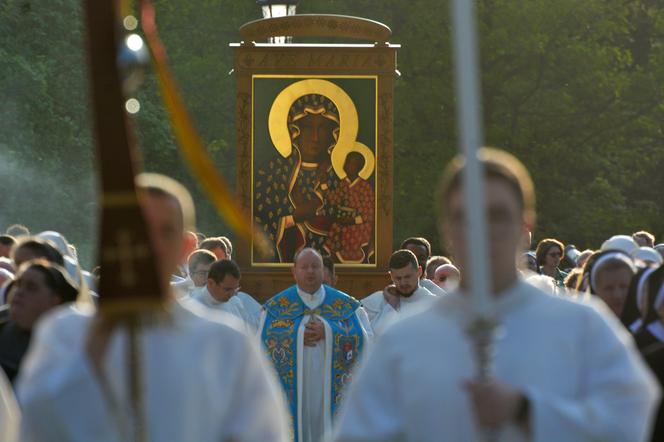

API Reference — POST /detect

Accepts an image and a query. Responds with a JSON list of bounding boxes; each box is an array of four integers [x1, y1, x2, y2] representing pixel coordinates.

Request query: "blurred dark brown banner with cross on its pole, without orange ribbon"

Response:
[[83, 0, 161, 442]]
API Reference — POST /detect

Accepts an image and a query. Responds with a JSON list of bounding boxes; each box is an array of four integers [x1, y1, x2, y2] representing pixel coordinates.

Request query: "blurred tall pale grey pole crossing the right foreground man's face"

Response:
[[452, 0, 492, 318]]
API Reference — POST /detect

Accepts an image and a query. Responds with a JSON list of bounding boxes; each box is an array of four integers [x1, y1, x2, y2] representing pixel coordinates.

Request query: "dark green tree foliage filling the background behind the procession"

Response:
[[0, 0, 664, 265]]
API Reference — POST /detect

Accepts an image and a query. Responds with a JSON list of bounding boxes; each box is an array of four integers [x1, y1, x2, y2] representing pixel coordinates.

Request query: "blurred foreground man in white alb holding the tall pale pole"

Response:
[[337, 149, 659, 442]]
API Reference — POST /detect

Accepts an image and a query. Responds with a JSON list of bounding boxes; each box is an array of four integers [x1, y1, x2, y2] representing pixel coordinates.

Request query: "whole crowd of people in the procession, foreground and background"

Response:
[[0, 149, 664, 442]]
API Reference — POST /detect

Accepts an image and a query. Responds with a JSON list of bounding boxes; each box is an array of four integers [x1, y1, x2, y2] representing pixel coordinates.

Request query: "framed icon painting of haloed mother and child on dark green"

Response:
[[251, 75, 379, 266]]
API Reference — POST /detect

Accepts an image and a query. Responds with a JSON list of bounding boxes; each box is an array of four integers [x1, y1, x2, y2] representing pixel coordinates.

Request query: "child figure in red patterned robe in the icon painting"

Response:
[[325, 151, 375, 263]]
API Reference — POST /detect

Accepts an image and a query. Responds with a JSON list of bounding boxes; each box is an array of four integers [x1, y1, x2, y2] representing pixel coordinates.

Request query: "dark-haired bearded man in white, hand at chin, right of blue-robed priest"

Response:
[[362, 249, 435, 336]]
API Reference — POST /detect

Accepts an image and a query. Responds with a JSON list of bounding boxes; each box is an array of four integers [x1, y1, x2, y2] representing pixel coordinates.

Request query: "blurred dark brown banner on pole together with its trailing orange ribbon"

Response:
[[83, 0, 262, 441]]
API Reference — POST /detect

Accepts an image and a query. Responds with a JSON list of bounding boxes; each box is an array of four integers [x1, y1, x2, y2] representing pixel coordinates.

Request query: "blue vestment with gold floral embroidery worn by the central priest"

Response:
[[261, 285, 364, 441]]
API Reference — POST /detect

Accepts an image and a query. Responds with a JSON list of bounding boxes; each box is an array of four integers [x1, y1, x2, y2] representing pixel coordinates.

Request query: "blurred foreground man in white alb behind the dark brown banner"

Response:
[[17, 174, 287, 442]]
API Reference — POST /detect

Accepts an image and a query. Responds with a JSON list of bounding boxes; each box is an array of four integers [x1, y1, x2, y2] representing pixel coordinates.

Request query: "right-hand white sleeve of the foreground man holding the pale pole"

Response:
[[526, 306, 660, 442]]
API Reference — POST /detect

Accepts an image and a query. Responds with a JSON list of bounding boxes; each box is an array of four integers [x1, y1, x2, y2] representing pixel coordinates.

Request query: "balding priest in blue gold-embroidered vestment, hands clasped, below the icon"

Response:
[[260, 248, 373, 442]]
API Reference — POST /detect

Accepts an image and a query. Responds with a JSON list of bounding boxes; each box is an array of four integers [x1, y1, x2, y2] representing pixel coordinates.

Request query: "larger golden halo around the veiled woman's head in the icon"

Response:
[[268, 78, 359, 159]]
